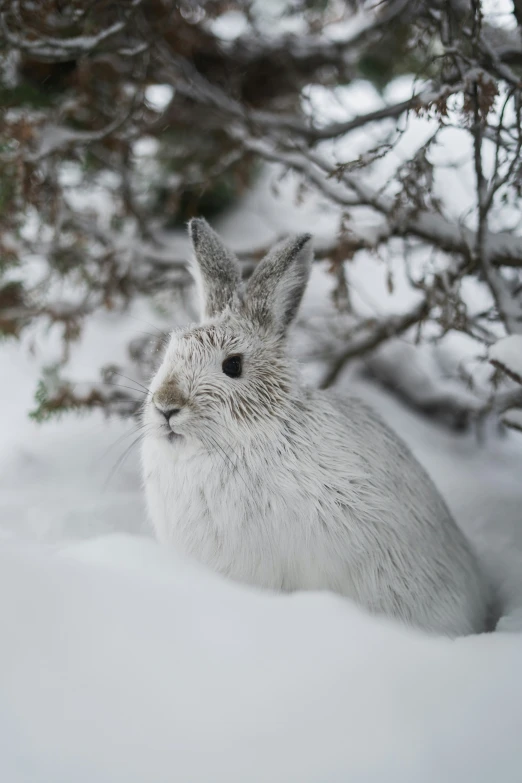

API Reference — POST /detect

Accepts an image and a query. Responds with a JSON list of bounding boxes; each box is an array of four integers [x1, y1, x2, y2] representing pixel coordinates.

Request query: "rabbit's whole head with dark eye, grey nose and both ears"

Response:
[[145, 219, 312, 442]]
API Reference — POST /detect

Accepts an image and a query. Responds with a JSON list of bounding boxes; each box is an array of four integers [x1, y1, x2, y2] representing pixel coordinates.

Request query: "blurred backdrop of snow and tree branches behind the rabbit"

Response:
[[0, 0, 522, 551]]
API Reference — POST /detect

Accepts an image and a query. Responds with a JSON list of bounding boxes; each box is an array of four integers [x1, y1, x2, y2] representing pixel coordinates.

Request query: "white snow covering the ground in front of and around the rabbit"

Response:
[[0, 168, 522, 783]]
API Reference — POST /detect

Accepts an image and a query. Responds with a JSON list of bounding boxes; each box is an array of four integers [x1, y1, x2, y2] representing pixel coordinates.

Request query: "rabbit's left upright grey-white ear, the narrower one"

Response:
[[189, 218, 241, 318]]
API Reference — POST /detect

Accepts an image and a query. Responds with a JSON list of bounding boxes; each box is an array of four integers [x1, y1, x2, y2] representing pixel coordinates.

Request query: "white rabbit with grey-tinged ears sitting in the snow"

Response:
[[142, 219, 488, 637]]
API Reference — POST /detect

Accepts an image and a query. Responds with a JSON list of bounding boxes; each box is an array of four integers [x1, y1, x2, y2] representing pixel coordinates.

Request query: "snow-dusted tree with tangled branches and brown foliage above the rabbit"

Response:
[[0, 0, 522, 426]]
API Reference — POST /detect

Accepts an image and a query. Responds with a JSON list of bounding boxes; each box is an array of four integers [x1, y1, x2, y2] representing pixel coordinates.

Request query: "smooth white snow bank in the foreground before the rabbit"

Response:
[[0, 537, 522, 783]]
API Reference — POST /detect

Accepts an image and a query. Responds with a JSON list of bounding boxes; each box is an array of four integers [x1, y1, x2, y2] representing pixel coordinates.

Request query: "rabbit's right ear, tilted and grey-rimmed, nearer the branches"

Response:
[[245, 234, 313, 333]]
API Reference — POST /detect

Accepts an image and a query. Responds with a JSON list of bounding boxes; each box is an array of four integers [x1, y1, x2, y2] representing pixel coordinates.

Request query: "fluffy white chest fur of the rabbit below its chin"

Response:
[[146, 440, 338, 589]]
